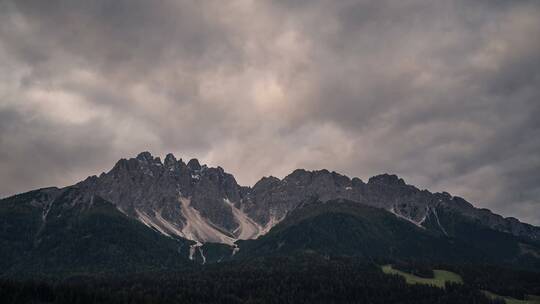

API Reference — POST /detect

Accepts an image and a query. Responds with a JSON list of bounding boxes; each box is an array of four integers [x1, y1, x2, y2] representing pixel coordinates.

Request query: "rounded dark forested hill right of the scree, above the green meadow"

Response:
[[235, 200, 540, 269]]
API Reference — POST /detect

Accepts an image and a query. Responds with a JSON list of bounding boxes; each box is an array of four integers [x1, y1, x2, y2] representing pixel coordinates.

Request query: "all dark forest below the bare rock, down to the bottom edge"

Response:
[[0, 191, 540, 304]]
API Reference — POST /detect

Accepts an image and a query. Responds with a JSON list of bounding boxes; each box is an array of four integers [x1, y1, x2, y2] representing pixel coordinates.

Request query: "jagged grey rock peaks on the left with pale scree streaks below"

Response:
[[73, 152, 250, 244]]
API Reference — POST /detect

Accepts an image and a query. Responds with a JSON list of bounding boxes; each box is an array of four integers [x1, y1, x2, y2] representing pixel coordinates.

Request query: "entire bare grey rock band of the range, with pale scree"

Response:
[[5, 152, 540, 245]]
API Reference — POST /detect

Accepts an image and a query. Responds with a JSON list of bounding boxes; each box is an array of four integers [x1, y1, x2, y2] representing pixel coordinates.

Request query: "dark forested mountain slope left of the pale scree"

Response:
[[0, 188, 192, 276]]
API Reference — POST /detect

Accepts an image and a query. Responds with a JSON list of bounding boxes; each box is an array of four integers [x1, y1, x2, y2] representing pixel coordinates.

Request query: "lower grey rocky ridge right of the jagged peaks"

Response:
[[242, 169, 540, 241]]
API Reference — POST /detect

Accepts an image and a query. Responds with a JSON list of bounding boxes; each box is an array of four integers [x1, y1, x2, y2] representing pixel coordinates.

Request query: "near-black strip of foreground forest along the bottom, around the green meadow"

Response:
[[0, 255, 540, 304]]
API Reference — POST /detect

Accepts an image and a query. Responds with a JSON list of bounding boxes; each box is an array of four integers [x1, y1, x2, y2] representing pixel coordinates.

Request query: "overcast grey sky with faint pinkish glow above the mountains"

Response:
[[0, 0, 540, 225]]
